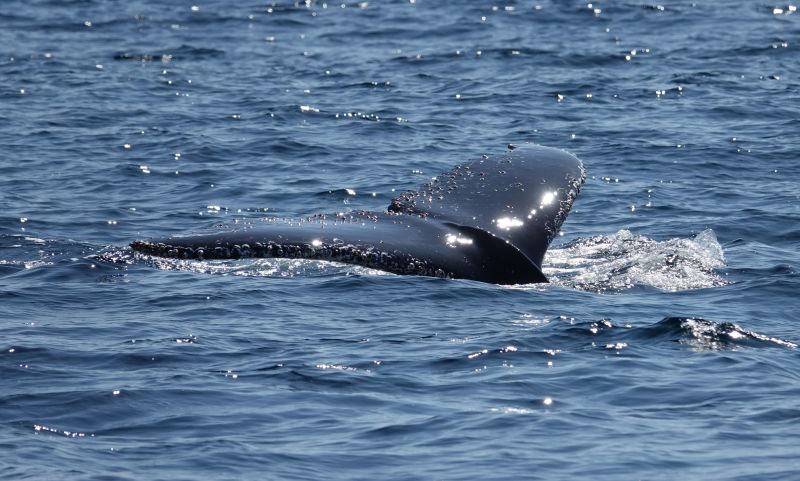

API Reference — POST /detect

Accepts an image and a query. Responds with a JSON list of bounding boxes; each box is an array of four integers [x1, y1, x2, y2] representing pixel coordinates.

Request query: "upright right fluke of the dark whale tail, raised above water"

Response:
[[389, 145, 585, 268]]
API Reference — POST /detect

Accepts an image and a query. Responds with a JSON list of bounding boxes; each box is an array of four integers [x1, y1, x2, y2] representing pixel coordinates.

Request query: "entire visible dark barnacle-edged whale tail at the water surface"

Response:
[[131, 144, 586, 284]]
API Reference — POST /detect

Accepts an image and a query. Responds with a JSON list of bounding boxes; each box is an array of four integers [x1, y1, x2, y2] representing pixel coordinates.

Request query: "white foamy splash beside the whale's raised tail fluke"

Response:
[[544, 229, 727, 292]]
